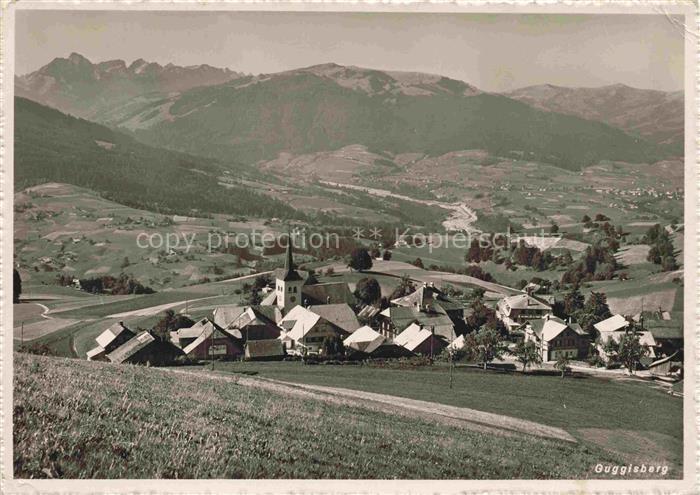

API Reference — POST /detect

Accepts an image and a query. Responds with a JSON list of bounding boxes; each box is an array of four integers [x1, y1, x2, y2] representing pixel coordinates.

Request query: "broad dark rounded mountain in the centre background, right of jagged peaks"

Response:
[[119, 69, 668, 169]]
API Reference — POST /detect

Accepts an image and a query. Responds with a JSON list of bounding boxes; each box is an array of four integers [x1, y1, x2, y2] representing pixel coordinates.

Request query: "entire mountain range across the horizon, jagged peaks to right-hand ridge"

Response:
[[16, 54, 683, 169]]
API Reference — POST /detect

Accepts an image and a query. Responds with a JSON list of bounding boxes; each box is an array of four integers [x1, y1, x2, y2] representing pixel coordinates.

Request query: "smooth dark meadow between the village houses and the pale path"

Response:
[[216, 362, 683, 467]]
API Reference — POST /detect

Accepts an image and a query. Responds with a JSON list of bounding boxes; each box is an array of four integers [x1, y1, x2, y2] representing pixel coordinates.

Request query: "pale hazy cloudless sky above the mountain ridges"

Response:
[[15, 10, 684, 91]]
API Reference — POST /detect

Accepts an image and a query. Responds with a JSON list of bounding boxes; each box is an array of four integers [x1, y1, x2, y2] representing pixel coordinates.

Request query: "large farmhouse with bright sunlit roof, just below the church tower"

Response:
[[280, 306, 352, 353]]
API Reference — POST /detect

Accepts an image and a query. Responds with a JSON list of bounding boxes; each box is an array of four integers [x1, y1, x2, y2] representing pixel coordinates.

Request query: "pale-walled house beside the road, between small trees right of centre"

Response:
[[524, 315, 590, 361]]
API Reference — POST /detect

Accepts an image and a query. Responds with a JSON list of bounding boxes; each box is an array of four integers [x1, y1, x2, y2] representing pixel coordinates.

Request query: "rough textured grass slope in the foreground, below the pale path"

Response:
[[13, 354, 623, 479]]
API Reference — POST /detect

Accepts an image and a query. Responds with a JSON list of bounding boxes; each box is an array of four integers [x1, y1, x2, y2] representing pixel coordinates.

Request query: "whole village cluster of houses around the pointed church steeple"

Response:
[[86, 241, 683, 384]]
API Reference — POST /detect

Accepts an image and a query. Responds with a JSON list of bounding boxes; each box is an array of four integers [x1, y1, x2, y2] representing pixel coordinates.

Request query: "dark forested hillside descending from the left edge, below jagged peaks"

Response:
[[15, 98, 303, 218]]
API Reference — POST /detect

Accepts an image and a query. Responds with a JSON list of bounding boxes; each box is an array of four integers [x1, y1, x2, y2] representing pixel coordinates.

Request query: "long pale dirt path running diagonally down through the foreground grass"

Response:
[[168, 369, 576, 442]]
